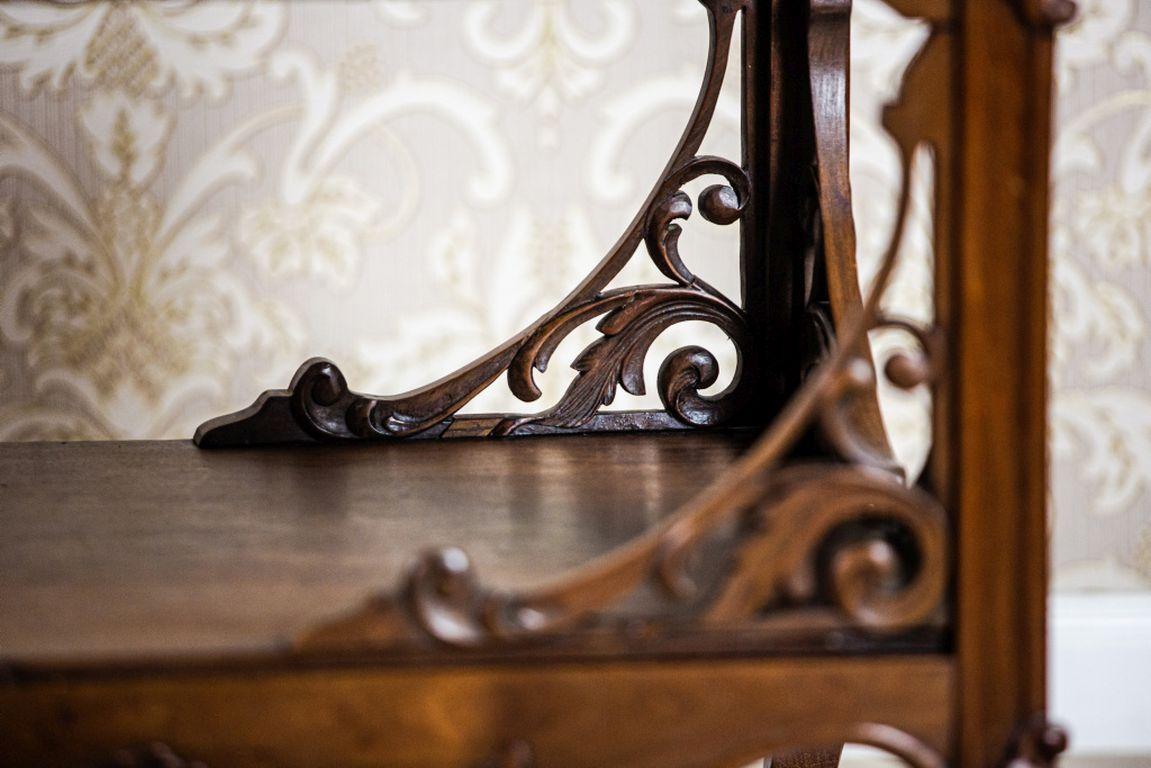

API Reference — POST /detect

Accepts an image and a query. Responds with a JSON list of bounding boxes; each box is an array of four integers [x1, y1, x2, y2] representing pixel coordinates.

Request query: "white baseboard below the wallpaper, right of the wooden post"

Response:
[[1047, 592, 1151, 765]]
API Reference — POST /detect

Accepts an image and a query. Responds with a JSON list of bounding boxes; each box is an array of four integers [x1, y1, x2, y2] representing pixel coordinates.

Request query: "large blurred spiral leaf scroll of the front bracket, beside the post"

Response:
[[699, 466, 947, 632]]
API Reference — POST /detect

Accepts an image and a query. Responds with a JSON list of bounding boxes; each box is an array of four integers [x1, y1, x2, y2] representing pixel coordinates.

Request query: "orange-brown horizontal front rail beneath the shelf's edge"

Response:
[[0, 656, 954, 768]]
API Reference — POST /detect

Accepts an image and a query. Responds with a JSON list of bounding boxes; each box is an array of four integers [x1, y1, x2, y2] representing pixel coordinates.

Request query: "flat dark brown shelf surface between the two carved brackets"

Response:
[[0, 433, 750, 661]]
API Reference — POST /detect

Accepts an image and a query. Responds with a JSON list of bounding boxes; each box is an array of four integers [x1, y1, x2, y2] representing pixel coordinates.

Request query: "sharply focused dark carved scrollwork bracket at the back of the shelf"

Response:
[[196, 0, 757, 448]]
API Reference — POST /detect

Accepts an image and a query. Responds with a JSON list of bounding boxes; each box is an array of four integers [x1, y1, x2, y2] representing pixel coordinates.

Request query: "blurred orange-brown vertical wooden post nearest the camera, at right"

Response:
[[950, 0, 1052, 767]]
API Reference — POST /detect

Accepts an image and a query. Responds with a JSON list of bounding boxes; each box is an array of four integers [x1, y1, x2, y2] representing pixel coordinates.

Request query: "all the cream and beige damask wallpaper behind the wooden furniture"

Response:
[[0, 0, 1151, 588]]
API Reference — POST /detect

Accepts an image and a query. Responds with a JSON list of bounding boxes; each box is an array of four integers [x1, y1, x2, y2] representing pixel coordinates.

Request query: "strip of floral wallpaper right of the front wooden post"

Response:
[[1050, 0, 1151, 590]]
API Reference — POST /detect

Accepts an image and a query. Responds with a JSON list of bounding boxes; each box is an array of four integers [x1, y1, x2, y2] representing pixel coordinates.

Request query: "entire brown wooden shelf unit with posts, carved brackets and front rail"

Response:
[[0, 0, 1074, 768]]
